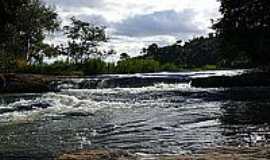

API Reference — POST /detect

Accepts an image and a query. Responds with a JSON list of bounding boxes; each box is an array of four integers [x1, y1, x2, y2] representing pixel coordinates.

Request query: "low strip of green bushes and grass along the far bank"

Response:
[[17, 58, 217, 76]]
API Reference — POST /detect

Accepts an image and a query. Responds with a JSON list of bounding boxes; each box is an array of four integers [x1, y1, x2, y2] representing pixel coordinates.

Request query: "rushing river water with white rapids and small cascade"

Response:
[[0, 71, 270, 159]]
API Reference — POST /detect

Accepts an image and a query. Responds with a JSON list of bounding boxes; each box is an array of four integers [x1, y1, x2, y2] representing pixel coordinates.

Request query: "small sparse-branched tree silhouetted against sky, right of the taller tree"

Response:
[[64, 17, 107, 64]]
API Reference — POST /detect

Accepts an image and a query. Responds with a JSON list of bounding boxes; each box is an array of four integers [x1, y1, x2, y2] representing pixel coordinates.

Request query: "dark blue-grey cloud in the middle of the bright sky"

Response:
[[114, 9, 203, 37]]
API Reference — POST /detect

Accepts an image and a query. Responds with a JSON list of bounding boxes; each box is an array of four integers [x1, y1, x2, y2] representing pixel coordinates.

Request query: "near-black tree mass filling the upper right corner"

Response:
[[213, 0, 270, 65]]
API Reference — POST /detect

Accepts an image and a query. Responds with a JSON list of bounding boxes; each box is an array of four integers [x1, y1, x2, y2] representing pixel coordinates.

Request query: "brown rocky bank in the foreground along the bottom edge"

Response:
[[57, 146, 270, 160]]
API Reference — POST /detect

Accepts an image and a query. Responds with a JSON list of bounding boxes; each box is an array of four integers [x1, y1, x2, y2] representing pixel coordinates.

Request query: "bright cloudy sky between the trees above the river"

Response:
[[43, 0, 220, 56]]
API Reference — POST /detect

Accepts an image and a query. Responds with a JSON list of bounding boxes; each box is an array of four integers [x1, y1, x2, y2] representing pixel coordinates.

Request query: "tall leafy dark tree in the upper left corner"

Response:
[[0, 0, 59, 71]]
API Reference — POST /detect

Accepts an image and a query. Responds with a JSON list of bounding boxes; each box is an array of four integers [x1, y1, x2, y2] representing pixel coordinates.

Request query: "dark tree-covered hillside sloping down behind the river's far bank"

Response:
[[141, 35, 220, 68]]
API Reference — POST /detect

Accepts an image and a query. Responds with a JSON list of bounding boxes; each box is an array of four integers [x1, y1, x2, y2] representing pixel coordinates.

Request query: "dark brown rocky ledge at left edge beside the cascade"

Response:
[[0, 73, 52, 93]]
